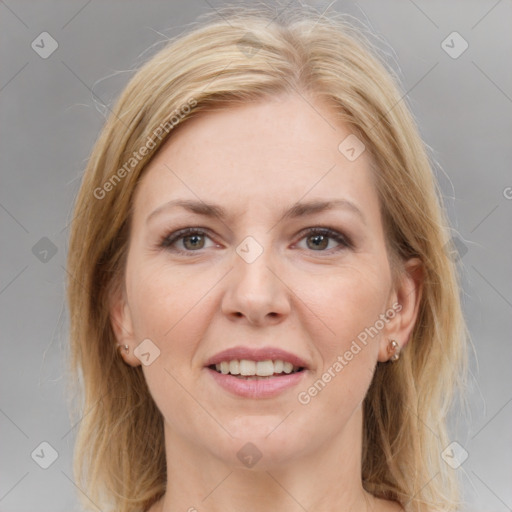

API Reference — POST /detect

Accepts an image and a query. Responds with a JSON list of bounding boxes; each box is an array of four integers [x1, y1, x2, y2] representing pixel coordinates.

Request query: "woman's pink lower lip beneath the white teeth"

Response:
[[206, 368, 306, 398]]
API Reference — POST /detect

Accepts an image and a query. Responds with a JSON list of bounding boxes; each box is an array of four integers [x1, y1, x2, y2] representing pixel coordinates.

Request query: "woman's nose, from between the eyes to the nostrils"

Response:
[[222, 238, 291, 326]]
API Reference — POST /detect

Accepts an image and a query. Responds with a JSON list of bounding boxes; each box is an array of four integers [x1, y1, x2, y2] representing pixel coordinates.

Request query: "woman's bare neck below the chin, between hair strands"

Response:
[[151, 408, 386, 512]]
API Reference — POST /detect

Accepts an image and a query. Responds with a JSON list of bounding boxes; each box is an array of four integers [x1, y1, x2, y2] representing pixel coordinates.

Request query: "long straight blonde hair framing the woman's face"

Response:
[[67, 2, 467, 512]]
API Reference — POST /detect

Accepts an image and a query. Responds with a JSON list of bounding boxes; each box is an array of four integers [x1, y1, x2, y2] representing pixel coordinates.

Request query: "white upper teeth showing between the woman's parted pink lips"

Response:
[[207, 359, 305, 380]]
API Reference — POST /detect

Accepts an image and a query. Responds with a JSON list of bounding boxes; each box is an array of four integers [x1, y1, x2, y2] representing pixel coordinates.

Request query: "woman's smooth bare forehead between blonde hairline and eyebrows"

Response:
[[135, 95, 378, 226]]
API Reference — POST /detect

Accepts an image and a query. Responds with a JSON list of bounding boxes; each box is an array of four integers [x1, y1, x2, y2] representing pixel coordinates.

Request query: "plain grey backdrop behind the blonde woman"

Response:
[[0, 0, 512, 512]]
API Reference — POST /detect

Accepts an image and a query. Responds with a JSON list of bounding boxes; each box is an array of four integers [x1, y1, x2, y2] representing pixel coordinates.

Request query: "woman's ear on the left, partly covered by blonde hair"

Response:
[[109, 286, 141, 366]]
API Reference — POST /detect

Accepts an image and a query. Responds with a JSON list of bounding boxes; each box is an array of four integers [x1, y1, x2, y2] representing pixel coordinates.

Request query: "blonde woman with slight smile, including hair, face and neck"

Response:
[[68, 7, 465, 512]]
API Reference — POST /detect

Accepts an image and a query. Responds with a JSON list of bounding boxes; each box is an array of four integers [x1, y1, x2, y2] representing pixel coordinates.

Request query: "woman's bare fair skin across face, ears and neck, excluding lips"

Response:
[[111, 95, 421, 512]]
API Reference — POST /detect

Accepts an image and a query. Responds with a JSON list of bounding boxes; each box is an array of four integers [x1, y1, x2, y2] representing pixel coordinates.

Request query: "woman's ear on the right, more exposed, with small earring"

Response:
[[378, 258, 424, 363]]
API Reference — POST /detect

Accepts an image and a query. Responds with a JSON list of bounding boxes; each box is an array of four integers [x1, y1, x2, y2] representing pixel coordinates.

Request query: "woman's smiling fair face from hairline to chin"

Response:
[[112, 95, 420, 468]]
